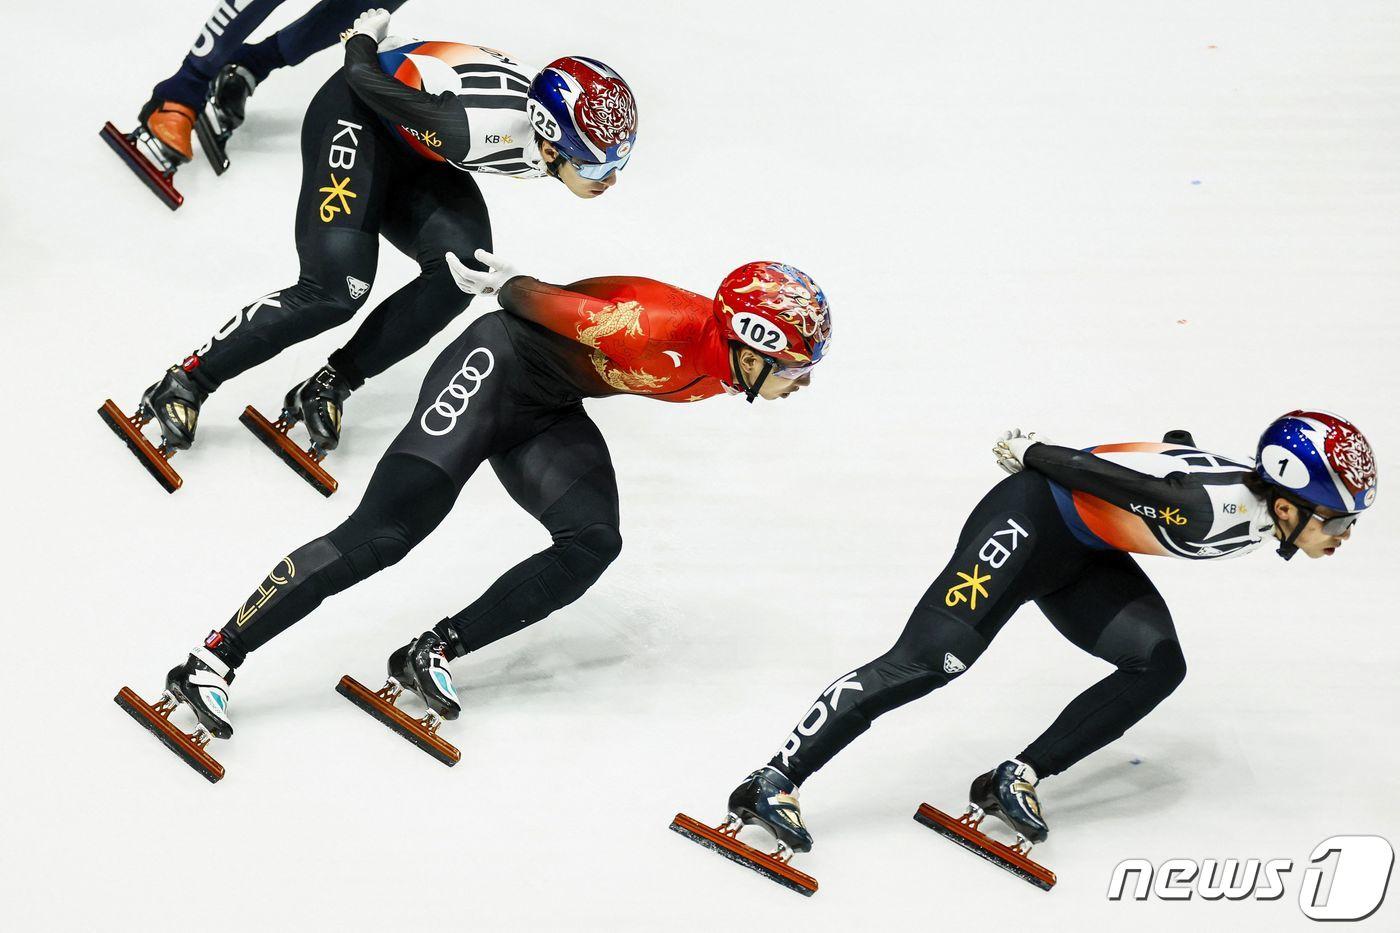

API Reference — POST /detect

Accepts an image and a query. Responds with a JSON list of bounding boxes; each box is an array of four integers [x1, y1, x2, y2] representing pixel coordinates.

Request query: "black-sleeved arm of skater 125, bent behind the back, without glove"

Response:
[[344, 34, 472, 163]]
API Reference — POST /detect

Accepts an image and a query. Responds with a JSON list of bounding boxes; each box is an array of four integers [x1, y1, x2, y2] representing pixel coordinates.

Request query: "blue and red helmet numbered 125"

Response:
[[526, 55, 637, 178]]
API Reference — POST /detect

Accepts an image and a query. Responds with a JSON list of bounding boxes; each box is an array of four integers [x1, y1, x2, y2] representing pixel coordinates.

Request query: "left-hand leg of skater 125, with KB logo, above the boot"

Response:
[[185, 74, 392, 392]]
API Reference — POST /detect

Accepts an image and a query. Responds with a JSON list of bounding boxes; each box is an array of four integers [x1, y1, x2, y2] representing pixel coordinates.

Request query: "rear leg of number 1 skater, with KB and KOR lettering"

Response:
[[769, 474, 1082, 785]]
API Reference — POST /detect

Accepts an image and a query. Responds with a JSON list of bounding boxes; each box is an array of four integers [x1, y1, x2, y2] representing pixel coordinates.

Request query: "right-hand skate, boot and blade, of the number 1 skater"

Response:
[[914, 759, 1056, 891]]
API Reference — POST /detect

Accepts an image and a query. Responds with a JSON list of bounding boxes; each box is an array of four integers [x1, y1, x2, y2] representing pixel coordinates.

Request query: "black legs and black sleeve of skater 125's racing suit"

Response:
[[185, 35, 491, 391]]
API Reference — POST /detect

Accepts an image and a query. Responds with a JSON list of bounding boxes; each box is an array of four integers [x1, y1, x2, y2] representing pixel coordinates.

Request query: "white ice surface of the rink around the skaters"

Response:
[[0, 0, 1400, 930]]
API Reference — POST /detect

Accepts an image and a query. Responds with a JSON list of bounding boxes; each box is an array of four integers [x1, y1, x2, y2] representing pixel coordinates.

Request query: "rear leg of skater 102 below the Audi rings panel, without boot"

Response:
[[212, 454, 458, 652]]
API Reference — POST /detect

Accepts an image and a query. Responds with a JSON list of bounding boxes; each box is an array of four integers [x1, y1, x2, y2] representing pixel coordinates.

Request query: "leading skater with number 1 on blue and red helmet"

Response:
[[675, 410, 1376, 887]]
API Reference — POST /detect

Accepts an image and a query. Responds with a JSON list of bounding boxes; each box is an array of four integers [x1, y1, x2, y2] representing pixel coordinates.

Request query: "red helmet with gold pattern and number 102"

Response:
[[714, 261, 832, 378]]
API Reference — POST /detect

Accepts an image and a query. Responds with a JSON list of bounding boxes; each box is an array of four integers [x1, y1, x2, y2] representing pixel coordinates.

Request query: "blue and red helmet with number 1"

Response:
[[1254, 409, 1376, 513]]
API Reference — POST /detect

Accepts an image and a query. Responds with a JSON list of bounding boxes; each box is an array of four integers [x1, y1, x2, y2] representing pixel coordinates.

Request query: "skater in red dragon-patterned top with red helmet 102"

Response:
[[118, 252, 832, 780]]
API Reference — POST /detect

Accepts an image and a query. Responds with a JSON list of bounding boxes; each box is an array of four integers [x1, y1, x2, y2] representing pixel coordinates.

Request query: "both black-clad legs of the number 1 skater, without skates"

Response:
[[769, 465, 1186, 785]]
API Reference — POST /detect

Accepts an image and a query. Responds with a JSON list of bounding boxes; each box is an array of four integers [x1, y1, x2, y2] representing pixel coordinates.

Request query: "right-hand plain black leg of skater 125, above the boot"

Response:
[[329, 163, 491, 388]]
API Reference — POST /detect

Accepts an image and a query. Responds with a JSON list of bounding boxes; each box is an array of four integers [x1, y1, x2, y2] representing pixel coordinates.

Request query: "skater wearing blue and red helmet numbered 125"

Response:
[[99, 10, 637, 496]]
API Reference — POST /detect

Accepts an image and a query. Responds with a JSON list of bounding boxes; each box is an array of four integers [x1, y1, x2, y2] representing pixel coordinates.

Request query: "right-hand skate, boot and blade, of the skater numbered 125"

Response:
[[238, 364, 350, 496]]
